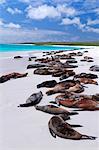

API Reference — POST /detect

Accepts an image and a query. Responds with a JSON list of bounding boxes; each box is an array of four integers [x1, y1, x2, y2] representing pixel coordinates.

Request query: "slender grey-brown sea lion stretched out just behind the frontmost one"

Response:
[[35, 105, 78, 115]]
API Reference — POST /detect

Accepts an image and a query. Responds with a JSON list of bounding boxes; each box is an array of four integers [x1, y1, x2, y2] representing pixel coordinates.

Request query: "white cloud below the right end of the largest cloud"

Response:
[[61, 17, 85, 29]]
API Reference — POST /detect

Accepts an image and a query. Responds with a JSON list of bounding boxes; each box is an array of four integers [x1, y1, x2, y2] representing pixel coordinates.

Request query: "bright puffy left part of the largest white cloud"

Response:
[[26, 5, 61, 20]]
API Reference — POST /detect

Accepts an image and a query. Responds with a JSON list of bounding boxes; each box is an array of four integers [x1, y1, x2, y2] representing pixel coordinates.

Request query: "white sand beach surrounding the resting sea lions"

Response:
[[0, 47, 99, 150]]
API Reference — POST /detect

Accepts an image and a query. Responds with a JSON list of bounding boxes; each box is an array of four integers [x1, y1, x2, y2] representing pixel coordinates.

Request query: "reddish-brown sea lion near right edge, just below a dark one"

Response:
[[74, 77, 98, 85]]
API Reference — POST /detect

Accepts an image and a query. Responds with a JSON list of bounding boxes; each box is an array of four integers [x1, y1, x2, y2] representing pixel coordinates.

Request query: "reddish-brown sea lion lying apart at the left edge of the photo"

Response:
[[0, 72, 28, 83]]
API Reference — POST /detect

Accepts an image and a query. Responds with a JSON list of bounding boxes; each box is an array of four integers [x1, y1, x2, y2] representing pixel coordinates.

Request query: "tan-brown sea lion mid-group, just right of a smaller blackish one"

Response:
[[46, 80, 77, 95]]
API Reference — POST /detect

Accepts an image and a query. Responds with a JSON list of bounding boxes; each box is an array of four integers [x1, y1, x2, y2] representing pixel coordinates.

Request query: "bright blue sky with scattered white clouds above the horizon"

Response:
[[0, 0, 99, 43]]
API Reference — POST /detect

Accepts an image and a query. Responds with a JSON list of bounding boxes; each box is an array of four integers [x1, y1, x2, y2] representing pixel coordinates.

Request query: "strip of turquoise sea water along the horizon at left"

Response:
[[0, 44, 79, 52]]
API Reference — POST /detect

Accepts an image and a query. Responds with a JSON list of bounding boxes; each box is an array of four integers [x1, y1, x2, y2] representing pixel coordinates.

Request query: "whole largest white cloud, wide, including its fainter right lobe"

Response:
[[26, 5, 77, 20]]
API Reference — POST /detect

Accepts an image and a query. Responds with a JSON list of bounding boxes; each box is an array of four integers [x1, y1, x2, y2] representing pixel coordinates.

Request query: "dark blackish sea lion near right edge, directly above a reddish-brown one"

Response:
[[74, 73, 98, 79]]
